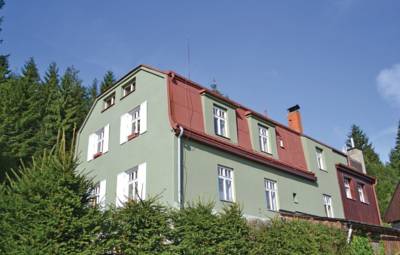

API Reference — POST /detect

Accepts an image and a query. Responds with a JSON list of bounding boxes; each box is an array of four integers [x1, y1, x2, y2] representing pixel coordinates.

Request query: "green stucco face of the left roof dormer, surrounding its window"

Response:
[[201, 94, 238, 144]]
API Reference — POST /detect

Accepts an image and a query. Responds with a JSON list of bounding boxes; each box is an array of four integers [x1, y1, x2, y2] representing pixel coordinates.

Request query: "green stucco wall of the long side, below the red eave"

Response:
[[183, 139, 343, 218]]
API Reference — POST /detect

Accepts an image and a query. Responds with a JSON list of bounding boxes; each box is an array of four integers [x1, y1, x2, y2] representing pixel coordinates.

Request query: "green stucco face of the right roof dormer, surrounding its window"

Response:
[[247, 116, 279, 159]]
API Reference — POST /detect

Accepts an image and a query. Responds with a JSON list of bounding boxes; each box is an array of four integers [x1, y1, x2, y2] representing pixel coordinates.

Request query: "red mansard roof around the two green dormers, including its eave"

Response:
[[168, 72, 316, 181]]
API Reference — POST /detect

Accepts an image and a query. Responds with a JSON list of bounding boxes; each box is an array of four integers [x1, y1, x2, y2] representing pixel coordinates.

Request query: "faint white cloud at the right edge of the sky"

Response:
[[376, 64, 400, 106]]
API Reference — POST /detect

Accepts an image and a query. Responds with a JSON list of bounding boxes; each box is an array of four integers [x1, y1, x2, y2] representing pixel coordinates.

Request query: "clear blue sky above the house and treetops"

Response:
[[0, 0, 400, 160]]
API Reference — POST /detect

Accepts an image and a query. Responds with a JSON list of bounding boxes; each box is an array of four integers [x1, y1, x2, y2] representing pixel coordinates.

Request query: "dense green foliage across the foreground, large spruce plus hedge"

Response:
[[0, 142, 348, 254]]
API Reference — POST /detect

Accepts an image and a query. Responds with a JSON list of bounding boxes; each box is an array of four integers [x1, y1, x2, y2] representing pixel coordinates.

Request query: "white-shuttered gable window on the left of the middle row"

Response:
[[87, 124, 110, 161]]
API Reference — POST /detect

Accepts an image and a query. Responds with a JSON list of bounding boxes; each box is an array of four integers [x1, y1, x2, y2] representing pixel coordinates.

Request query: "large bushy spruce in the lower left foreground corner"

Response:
[[0, 136, 103, 254]]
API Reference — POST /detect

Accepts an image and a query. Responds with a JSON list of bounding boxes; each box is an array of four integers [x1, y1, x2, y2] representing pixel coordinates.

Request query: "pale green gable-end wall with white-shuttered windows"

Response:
[[76, 68, 177, 206]]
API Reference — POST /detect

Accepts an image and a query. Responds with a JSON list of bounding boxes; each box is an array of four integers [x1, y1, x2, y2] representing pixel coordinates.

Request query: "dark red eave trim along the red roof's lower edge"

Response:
[[175, 126, 317, 181]]
